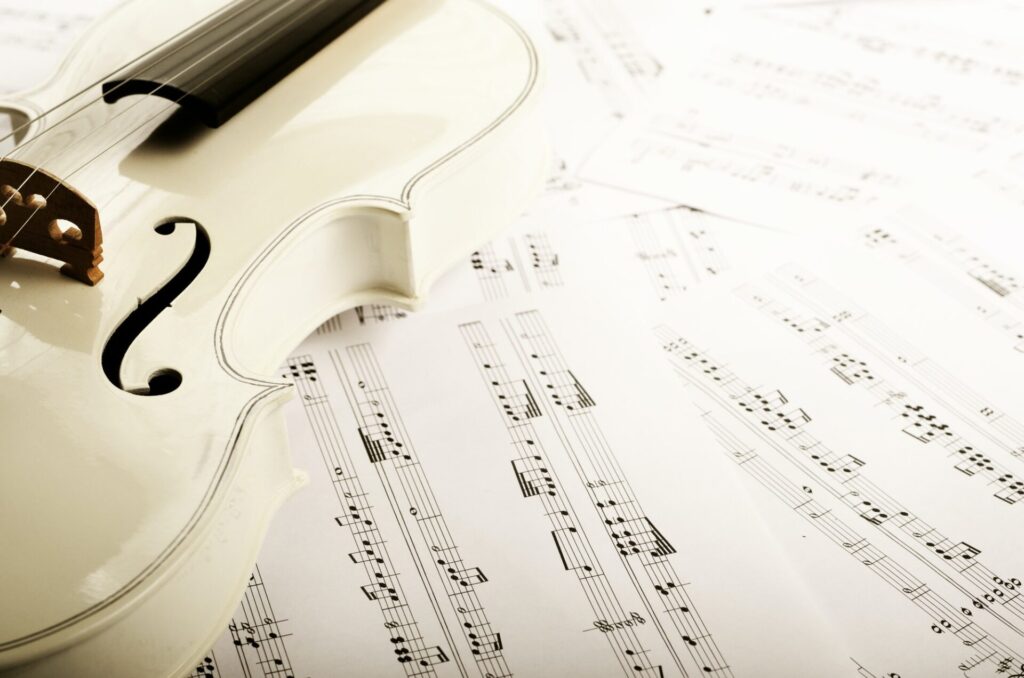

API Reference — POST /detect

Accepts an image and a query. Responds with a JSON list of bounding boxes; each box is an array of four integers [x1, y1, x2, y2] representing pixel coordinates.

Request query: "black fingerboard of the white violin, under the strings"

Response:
[[103, 0, 385, 127]]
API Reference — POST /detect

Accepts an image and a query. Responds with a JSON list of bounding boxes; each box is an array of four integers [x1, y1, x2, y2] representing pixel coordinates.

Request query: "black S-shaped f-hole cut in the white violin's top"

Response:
[[100, 219, 210, 395]]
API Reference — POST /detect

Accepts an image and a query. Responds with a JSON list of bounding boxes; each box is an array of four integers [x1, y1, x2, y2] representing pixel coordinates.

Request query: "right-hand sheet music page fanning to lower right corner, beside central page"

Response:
[[656, 236, 1024, 676]]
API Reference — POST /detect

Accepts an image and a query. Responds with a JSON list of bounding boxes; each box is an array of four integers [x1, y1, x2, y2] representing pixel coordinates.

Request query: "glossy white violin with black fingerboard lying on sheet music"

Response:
[[0, 0, 547, 678]]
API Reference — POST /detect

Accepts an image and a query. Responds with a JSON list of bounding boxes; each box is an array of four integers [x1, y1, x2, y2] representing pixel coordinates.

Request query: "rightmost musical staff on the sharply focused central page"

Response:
[[503, 311, 733, 676]]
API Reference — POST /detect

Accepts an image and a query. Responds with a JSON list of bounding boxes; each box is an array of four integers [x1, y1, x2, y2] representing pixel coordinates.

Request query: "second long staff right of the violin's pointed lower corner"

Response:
[[331, 344, 512, 678]]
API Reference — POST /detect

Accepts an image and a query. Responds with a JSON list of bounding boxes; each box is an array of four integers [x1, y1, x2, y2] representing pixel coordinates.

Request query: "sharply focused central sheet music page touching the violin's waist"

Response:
[[197, 293, 867, 676]]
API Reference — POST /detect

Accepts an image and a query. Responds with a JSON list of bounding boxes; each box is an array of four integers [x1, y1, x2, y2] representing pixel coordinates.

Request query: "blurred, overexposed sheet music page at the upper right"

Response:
[[581, 2, 1024, 232]]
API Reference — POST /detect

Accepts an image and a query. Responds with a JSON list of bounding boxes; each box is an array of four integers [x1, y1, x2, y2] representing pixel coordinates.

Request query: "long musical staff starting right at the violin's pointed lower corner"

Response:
[[287, 355, 449, 678]]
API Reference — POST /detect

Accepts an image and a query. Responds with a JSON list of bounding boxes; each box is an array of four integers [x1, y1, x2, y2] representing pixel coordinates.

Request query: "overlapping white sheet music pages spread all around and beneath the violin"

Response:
[[0, 0, 1024, 678]]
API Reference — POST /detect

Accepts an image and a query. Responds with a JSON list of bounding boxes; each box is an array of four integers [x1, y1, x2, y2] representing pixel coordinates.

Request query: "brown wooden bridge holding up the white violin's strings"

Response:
[[0, 160, 103, 286]]
